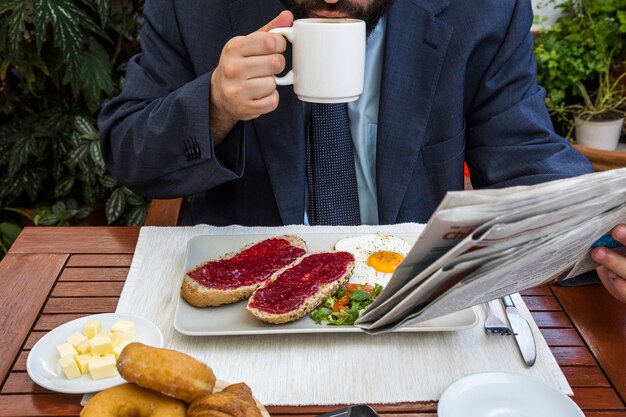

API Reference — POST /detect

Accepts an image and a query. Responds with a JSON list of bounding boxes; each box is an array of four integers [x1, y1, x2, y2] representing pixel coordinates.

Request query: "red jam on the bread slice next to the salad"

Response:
[[250, 252, 354, 314]]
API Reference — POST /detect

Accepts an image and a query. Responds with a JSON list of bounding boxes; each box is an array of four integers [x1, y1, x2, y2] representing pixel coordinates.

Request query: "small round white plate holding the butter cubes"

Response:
[[26, 313, 163, 394]]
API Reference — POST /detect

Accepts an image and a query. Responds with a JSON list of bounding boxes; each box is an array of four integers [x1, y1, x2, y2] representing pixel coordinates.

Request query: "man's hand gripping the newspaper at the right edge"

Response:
[[591, 224, 626, 303]]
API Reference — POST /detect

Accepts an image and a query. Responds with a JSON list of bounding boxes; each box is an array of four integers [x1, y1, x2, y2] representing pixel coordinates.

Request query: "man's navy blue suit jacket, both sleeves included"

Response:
[[99, 0, 591, 225]]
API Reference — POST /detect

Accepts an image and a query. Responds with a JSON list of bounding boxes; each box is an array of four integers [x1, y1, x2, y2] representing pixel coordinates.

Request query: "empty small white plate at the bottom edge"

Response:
[[437, 372, 585, 417]]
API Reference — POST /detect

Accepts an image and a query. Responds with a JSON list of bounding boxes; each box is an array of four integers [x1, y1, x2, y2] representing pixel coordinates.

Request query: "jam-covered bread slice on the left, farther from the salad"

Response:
[[181, 235, 307, 307]]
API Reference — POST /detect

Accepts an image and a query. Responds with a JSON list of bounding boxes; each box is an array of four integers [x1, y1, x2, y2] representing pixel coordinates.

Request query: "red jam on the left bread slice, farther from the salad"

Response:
[[187, 239, 306, 290]]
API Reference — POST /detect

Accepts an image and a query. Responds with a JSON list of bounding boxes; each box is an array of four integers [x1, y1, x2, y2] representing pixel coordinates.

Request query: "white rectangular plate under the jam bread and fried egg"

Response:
[[174, 233, 478, 336]]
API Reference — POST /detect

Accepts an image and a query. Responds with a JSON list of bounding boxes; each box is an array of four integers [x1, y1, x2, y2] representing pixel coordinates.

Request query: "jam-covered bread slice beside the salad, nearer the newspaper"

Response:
[[246, 251, 354, 324]]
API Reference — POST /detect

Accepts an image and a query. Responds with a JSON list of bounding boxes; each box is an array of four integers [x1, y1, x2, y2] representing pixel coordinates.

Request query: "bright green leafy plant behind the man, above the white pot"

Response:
[[535, 0, 626, 133]]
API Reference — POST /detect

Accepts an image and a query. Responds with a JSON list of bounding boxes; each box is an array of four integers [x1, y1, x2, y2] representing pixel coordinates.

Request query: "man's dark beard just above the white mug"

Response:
[[281, 0, 393, 35]]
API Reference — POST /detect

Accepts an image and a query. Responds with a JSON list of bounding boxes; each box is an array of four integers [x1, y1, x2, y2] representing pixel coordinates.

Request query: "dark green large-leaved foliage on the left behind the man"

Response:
[[0, 0, 149, 257]]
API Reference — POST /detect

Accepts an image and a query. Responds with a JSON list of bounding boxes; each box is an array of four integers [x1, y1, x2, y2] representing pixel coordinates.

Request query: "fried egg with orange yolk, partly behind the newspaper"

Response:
[[335, 233, 411, 287]]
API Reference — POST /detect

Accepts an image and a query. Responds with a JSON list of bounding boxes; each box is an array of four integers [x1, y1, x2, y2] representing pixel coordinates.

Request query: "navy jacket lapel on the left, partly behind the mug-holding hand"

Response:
[[230, 0, 306, 224]]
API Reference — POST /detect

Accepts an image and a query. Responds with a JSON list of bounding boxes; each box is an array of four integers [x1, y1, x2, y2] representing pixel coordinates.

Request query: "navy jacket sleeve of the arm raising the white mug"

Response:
[[99, 0, 244, 198]]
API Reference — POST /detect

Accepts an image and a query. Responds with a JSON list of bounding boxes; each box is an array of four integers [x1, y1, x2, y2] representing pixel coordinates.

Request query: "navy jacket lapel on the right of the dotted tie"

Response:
[[376, 0, 453, 224]]
